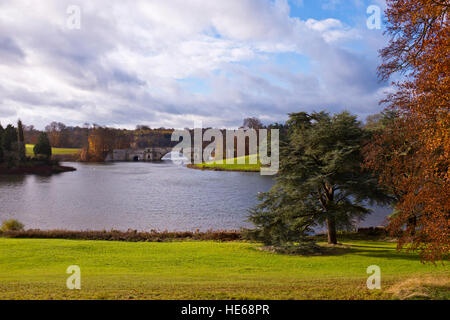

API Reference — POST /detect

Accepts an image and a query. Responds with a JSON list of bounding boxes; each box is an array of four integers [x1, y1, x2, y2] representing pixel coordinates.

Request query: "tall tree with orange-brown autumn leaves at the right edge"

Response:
[[366, 0, 450, 261]]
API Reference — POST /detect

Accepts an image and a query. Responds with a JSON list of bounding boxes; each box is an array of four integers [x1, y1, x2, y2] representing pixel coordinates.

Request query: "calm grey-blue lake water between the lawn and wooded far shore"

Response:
[[0, 161, 386, 231]]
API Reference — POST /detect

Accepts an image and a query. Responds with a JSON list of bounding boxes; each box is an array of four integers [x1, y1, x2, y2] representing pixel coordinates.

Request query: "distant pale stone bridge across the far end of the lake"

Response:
[[105, 147, 172, 161]]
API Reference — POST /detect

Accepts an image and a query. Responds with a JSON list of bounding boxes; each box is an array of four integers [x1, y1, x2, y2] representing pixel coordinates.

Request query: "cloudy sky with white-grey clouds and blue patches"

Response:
[[0, 0, 391, 129]]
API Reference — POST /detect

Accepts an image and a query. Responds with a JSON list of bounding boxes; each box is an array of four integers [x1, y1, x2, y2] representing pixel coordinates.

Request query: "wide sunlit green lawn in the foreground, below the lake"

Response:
[[0, 238, 450, 299]]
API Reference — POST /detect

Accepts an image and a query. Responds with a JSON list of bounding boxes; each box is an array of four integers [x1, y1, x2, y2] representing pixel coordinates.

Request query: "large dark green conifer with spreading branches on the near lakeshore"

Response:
[[249, 112, 389, 244]]
